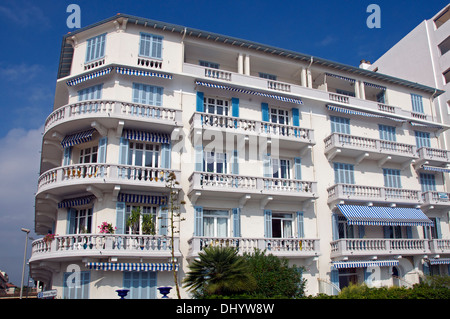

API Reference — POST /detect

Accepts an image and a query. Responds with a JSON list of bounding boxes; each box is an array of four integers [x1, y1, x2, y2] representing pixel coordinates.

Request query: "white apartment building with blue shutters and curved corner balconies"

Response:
[[30, 14, 450, 299]]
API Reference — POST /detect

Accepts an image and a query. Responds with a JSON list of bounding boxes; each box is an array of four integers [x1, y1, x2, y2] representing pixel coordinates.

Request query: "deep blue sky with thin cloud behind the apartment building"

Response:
[[0, 0, 448, 285]]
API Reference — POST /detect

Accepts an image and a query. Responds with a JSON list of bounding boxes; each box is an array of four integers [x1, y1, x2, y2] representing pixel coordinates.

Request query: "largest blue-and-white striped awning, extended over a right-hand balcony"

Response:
[[337, 205, 433, 226]]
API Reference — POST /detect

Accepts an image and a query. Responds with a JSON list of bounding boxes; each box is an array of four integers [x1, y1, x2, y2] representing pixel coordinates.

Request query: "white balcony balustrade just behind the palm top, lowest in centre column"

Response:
[[188, 237, 320, 257]]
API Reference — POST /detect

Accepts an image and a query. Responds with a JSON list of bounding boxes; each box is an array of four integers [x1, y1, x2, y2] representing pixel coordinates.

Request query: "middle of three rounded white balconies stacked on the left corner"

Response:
[[36, 163, 180, 198]]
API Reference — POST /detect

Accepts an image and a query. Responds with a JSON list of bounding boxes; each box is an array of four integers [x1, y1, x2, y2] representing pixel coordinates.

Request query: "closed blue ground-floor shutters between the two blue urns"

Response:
[[123, 271, 156, 299]]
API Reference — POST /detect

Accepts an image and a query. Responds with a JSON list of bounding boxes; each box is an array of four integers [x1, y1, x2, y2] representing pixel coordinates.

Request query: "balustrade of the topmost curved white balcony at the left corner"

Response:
[[44, 100, 181, 132]]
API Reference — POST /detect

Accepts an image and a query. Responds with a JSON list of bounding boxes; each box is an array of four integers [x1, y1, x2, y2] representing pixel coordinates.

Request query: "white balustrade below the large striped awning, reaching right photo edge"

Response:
[[331, 238, 450, 258]]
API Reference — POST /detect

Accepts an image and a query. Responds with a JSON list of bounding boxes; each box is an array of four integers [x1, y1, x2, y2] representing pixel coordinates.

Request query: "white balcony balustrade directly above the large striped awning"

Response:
[[327, 184, 422, 205]]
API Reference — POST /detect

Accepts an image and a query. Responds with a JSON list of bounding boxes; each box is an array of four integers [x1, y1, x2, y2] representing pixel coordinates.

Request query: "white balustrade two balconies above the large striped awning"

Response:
[[324, 133, 417, 157]]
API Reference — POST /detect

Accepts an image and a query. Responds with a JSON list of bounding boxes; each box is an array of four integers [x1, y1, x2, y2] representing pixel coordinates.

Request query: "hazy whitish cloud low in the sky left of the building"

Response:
[[0, 127, 43, 285]]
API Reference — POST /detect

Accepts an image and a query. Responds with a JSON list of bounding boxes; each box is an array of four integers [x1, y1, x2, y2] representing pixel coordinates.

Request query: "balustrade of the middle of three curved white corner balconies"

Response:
[[38, 163, 180, 192]]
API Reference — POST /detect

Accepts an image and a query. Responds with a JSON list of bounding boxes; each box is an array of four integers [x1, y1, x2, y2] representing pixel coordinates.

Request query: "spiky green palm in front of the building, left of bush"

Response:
[[183, 246, 256, 295]]
